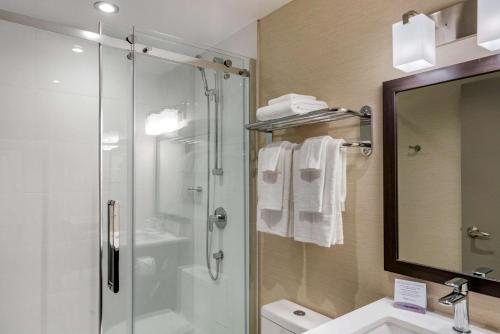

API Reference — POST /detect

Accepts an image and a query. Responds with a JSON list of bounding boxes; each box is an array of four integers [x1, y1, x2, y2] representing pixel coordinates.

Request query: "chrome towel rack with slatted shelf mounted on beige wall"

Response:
[[245, 106, 373, 156]]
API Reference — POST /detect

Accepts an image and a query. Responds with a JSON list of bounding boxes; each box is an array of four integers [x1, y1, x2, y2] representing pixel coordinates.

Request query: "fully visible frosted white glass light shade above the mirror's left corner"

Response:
[[392, 14, 436, 72]]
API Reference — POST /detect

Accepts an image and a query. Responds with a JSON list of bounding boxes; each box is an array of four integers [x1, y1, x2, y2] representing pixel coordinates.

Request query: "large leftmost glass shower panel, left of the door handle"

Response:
[[0, 21, 99, 334]]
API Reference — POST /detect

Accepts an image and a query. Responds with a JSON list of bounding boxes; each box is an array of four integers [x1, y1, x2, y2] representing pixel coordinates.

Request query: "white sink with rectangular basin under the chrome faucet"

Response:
[[305, 298, 497, 334]]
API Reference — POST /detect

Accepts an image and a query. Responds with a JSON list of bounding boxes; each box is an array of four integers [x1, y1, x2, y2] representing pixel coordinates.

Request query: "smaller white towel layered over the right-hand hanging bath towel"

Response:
[[294, 136, 333, 212]]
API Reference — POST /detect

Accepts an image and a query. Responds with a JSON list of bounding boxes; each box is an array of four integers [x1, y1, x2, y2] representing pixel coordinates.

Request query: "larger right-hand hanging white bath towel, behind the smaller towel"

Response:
[[293, 139, 346, 247]]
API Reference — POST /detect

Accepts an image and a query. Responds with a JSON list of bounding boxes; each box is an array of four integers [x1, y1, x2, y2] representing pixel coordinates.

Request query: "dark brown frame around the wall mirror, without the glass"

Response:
[[383, 55, 500, 297]]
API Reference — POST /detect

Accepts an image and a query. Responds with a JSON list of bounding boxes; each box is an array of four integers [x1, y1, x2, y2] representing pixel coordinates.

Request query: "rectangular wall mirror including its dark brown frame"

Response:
[[384, 56, 500, 297]]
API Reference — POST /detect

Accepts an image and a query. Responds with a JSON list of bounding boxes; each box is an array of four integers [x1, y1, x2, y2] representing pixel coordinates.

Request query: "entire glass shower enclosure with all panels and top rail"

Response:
[[0, 10, 251, 334]]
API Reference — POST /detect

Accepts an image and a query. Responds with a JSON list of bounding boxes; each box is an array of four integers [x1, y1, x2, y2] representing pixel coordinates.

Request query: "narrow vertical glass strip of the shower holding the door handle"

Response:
[[101, 46, 133, 334]]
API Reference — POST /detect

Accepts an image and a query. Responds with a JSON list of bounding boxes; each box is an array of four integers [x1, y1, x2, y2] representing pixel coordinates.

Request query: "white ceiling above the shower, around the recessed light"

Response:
[[0, 0, 290, 49]]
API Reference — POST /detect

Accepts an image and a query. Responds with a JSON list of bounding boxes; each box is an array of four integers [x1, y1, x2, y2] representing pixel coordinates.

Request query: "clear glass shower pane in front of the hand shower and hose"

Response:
[[134, 36, 248, 334]]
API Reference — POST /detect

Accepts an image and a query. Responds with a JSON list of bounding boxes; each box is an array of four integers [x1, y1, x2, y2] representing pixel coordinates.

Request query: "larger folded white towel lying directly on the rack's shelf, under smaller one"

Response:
[[257, 101, 328, 121]]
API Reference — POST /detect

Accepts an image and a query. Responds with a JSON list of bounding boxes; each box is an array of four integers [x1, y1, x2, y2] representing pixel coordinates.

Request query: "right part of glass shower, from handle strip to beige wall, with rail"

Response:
[[101, 30, 249, 334]]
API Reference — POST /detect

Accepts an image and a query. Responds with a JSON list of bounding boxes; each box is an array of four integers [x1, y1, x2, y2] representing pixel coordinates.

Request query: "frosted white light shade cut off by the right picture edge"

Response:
[[477, 0, 500, 51]]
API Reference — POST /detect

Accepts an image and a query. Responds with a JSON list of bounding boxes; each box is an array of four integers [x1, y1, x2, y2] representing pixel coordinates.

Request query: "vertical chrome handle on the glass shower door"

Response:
[[108, 200, 120, 293]]
